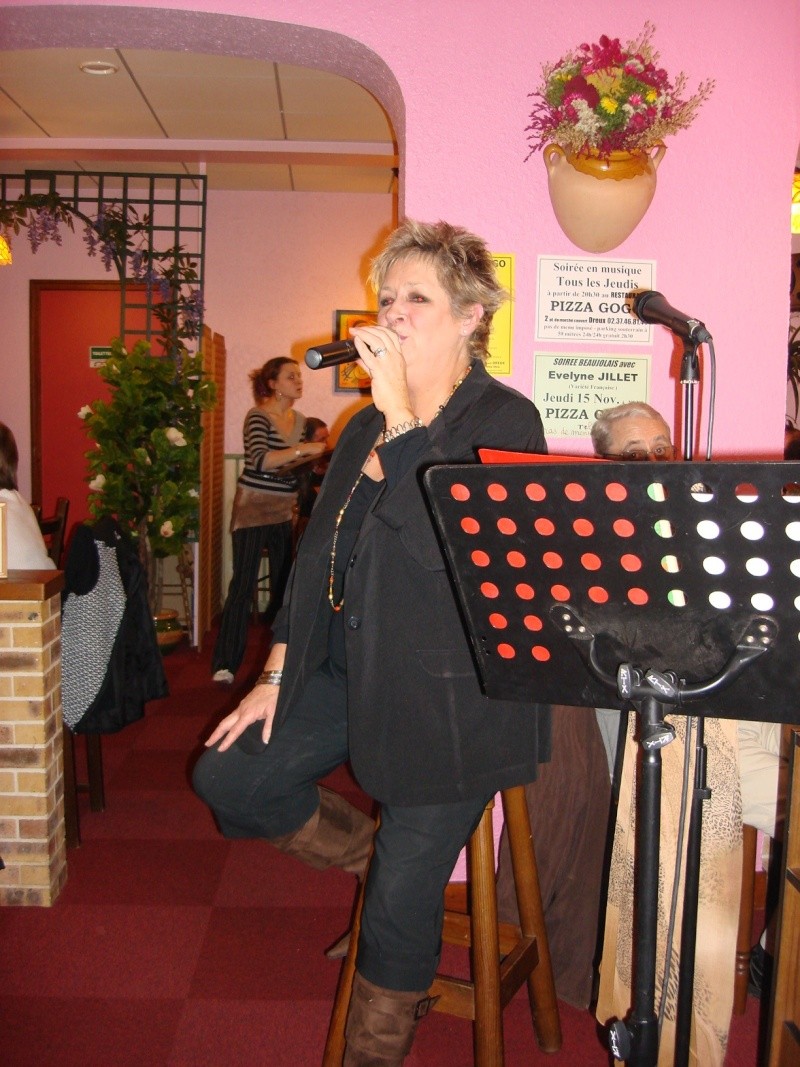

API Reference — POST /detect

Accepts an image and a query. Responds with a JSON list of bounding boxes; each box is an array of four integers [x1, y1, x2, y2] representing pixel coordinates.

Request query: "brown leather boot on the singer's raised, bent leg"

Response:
[[270, 785, 375, 878]]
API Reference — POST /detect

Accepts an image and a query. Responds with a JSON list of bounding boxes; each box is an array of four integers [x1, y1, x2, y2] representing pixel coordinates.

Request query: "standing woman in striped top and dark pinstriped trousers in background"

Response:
[[211, 356, 325, 685]]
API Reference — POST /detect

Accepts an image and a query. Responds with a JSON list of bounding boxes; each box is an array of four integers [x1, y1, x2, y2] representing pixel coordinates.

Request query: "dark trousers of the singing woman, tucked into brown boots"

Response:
[[193, 665, 493, 991]]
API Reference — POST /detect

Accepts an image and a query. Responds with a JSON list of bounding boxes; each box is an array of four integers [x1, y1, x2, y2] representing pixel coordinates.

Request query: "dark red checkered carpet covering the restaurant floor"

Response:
[[0, 626, 759, 1067]]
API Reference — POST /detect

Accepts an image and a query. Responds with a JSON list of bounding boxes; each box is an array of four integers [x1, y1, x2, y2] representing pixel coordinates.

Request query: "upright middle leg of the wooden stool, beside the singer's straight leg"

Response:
[[469, 800, 505, 1067]]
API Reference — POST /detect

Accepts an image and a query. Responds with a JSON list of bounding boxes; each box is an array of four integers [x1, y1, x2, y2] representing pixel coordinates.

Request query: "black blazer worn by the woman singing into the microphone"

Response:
[[275, 363, 549, 805]]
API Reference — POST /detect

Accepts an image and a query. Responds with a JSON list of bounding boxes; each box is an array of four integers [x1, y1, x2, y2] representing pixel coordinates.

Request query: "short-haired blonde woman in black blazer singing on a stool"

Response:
[[194, 221, 549, 1067]]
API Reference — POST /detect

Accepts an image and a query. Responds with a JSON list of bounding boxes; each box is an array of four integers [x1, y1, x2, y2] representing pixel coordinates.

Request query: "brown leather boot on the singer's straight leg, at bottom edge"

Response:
[[341, 971, 436, 1067]]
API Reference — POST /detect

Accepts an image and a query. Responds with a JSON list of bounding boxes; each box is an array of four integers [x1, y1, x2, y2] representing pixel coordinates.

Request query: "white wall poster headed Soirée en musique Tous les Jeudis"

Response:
[[537, 256, 655, 345]]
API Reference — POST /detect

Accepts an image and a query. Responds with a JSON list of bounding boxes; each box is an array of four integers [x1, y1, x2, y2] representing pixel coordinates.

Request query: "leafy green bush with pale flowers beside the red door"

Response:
[[78, 338, 217, 614]]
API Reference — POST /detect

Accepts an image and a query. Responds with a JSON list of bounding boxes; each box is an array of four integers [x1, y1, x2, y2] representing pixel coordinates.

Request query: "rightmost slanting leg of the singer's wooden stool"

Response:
[[502, 785, 561, 1052]]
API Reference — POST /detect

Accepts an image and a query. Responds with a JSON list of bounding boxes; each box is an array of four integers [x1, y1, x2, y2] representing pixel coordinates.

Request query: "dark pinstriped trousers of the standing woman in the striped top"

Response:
[[211, 523, 291, 674]]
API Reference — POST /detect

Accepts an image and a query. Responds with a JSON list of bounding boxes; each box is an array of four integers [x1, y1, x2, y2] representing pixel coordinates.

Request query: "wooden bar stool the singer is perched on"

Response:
[[322, 785, 561, 1067]]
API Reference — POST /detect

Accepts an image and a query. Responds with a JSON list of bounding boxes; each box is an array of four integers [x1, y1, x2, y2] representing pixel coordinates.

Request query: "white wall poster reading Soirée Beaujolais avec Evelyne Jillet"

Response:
[[533, 352, 650, 437]]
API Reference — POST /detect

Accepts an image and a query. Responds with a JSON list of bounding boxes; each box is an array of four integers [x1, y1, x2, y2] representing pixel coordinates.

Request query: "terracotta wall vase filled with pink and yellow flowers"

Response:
[[526, 22, 714, 252]]
